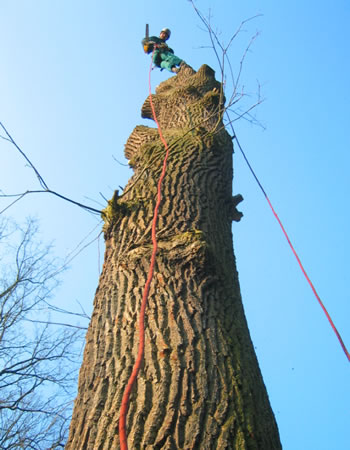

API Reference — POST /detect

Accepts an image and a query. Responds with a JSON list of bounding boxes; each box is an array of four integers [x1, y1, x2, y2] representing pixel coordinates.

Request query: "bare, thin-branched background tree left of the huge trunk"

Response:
[[0, 219, 87, 449]]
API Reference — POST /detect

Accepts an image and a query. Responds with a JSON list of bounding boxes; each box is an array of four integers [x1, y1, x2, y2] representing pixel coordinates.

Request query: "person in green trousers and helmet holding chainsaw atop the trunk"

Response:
[[142, 28, 183, 73]]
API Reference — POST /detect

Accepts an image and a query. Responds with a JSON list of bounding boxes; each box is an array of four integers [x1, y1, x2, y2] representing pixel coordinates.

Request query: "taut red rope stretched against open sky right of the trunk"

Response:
[[229, 125, 350, 361]]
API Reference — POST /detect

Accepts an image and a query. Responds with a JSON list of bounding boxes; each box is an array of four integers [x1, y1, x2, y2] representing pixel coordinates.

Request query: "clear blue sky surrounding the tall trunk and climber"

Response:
[[0, 0, 350, 450]]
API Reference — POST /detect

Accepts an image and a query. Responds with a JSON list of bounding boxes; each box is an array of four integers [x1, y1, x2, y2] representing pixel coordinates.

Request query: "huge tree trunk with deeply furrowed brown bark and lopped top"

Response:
[[66, 66, 281, 450]]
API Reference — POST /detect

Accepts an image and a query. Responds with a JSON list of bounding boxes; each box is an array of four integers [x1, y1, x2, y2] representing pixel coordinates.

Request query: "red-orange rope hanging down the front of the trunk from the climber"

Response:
[[119, 60, 169, 450]]
